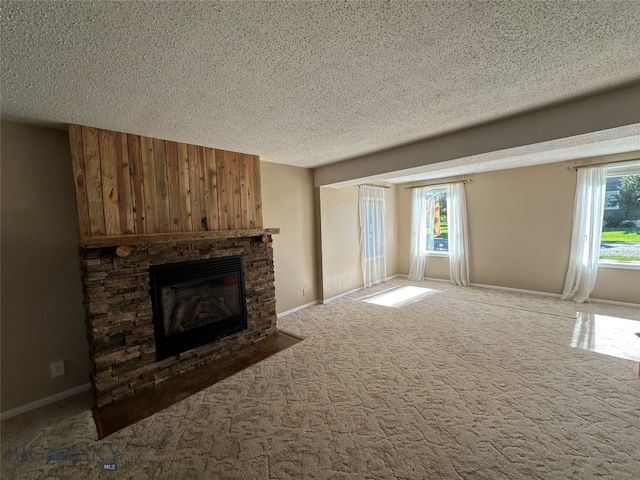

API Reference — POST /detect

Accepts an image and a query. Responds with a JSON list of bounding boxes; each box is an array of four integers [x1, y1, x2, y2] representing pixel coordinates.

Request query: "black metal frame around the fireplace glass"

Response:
[[149, 255, 247, 361]]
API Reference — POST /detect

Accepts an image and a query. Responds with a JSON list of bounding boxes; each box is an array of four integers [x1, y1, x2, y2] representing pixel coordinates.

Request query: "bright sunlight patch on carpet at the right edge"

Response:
[[571, 313, 640, 361]]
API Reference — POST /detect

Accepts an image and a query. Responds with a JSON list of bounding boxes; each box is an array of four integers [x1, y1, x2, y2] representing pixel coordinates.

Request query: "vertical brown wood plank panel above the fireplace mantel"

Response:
[[69, 125, 262, 237]]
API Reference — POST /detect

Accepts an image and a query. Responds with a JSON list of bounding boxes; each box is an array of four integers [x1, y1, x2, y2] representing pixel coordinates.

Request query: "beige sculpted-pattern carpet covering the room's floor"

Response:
[[1, 280, 640, 480]]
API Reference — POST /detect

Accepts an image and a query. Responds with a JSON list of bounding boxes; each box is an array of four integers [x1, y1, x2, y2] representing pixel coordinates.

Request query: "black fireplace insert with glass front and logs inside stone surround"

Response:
[[149, 255, 247, 360]]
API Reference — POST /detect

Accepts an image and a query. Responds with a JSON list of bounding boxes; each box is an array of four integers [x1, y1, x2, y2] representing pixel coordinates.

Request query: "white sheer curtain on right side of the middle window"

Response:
[[447, 183, 469, 287]]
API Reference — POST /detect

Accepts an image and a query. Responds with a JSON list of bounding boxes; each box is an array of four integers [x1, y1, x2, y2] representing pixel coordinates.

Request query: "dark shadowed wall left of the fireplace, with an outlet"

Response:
[[1, 122, 89, 411]]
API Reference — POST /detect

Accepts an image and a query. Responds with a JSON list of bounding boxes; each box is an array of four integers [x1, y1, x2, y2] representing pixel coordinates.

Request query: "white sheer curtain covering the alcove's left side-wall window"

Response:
[[358, 185, 387, 287]]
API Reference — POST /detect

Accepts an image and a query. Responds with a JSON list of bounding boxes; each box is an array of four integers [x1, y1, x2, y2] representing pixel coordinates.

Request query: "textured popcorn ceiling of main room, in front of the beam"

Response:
[[1, 0, 640, 167]]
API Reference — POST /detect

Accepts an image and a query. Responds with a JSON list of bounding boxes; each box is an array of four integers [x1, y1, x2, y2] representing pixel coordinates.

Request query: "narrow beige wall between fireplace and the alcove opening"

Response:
[[260, 162, 320, 313]]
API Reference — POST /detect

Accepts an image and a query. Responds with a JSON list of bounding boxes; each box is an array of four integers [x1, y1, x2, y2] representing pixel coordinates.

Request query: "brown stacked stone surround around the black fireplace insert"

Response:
[[80, 237, 277, 407]]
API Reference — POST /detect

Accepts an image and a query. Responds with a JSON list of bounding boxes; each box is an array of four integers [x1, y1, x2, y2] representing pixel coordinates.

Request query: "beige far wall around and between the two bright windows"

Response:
[[398, 159, 640, 303]]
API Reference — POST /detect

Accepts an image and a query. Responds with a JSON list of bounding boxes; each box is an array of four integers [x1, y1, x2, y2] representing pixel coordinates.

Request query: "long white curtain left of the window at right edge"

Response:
[[562, 165, 607, 303]]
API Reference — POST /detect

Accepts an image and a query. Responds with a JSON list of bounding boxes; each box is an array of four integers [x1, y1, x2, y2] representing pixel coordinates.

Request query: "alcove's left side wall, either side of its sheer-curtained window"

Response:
[[320, 186, 398, 300]]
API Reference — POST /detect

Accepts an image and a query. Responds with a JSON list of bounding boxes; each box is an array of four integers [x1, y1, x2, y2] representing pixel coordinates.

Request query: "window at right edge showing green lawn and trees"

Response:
[[600, 164, 640, 264]]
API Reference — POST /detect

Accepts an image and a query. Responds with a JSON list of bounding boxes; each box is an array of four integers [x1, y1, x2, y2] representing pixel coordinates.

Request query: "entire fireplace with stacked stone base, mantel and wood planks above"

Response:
[[69, 125, 279, 408]]
